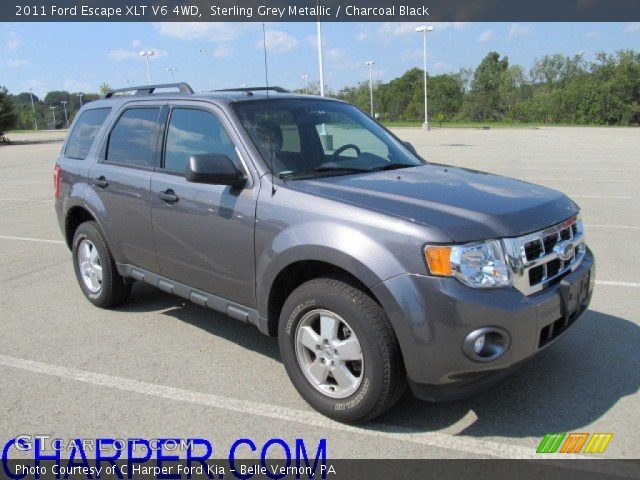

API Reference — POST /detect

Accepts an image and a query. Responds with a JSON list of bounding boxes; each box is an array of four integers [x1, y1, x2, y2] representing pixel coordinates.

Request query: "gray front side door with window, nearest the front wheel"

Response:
[[151, 101, 258, 307]]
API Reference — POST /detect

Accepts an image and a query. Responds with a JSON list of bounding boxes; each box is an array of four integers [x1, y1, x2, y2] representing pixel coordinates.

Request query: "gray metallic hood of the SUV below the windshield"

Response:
[[288, 164, 579, 242]]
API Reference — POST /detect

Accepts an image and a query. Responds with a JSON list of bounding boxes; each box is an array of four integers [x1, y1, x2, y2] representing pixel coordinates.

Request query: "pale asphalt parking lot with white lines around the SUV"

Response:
[[0, 128, 640, 458]]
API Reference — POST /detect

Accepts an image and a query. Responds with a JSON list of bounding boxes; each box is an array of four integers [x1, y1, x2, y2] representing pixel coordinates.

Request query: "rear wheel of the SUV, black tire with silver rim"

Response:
[[72, 221, 131, 308]]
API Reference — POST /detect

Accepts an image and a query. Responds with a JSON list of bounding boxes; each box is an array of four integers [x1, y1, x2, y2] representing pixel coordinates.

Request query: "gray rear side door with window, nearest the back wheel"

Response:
[[91, 102, 162, 272]]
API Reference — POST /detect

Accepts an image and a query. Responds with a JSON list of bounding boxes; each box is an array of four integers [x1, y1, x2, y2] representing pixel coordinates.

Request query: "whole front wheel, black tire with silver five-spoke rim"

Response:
[[278, 278, 407, 423]]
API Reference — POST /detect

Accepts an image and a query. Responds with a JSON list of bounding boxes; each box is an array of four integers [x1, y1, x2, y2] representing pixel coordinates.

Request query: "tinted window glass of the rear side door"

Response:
[[106, 108, 160, 167]]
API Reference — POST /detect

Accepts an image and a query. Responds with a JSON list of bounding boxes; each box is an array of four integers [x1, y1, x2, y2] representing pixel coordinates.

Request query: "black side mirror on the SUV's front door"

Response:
[[185, 153, 247, 187]]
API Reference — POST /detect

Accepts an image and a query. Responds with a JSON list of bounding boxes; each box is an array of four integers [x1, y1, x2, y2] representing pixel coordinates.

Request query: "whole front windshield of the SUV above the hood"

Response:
[[233, 99, 423, 178]]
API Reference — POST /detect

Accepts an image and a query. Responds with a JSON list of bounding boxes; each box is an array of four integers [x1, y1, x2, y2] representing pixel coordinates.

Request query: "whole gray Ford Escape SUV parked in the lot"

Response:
[[54, 84, 594, 422]]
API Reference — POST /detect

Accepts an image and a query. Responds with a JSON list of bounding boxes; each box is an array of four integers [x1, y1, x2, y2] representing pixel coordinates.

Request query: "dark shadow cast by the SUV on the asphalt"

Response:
[[118, 282, 640, 437]]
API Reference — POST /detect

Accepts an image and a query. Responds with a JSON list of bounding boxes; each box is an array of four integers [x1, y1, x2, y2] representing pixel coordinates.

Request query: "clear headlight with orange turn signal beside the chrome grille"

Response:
[[424, 240, 511, 288]]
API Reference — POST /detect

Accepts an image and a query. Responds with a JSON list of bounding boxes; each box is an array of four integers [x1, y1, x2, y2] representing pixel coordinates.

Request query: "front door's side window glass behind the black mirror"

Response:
[[164, 108, 237, 173]]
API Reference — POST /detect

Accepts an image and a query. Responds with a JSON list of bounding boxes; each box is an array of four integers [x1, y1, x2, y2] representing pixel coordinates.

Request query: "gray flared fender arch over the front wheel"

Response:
[[256, 221, 406, 318]]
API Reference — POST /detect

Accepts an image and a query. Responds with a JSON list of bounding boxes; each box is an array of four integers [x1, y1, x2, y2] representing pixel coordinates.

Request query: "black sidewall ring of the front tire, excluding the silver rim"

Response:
[[278, 282, 385, 422]]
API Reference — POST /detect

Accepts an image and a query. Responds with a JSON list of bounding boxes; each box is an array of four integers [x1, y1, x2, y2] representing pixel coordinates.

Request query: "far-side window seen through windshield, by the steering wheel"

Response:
[[316, 112, 389, 159]]
